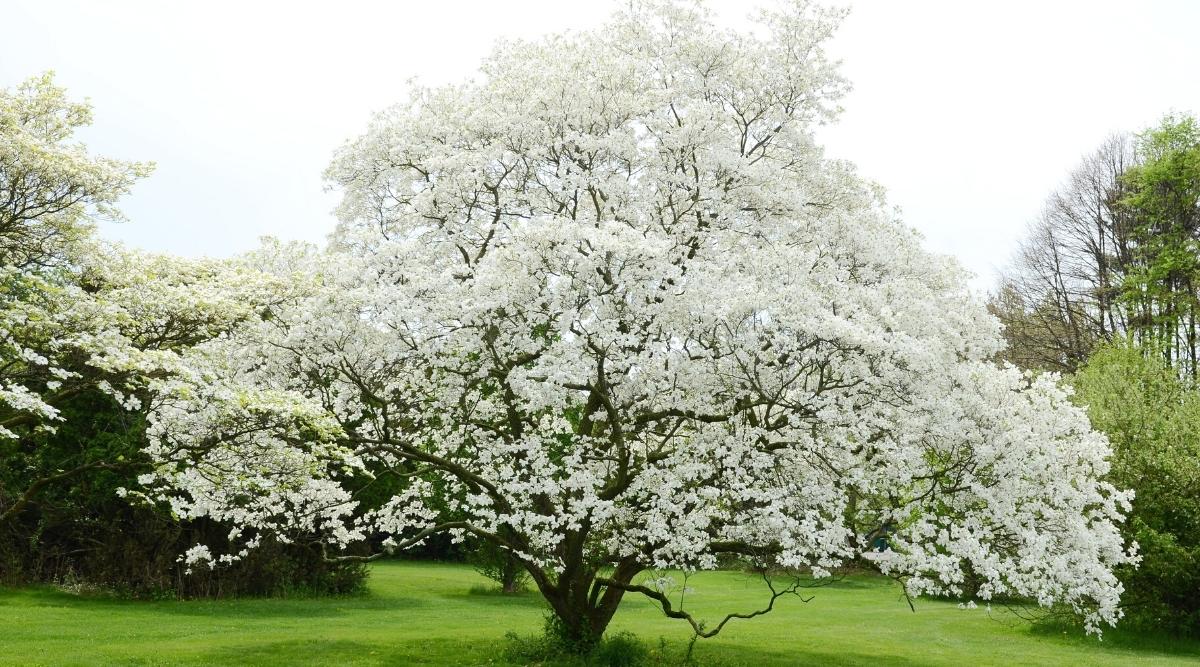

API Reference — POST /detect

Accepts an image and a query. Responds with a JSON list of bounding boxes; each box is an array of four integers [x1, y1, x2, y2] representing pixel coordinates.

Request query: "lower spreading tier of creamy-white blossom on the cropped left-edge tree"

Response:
[[0, 239, 277, 448]]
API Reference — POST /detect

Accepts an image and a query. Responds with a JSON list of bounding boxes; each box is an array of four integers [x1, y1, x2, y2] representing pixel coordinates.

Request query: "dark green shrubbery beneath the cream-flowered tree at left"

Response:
[[0, 391, 366, 599]]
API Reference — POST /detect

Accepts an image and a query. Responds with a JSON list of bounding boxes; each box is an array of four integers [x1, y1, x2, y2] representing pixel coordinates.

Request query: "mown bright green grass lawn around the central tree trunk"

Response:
[[0, 563, 1200, 667]]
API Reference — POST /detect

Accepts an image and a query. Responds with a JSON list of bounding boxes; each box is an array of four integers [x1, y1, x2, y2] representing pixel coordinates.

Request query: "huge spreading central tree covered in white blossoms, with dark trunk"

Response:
[[146, 2, 1132, 644]]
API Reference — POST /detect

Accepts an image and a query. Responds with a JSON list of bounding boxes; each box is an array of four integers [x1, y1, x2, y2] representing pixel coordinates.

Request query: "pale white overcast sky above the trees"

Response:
[[0, 0, 1200, 289]]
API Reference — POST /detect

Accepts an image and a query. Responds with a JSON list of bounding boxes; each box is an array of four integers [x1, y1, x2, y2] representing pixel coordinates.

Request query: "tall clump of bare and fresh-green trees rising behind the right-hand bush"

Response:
[[989, 116, 1200, 378]]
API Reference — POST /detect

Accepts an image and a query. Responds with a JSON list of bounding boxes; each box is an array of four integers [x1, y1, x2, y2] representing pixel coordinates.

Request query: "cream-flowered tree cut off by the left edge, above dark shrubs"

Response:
[[0, 74, 275, 525]]
